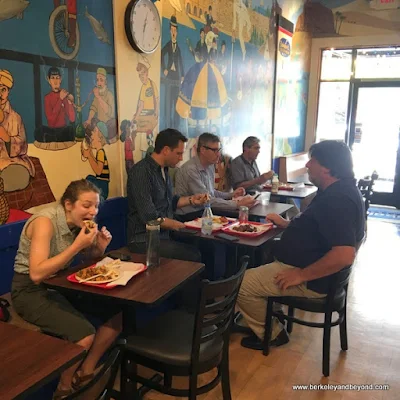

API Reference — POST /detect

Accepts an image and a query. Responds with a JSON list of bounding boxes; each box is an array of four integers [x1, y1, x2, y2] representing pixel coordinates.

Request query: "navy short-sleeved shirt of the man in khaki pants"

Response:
[[274, 179, 365, 293]]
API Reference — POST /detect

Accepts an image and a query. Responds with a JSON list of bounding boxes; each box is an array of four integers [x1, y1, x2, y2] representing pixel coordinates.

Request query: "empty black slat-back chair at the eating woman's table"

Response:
[[121, 256, 249, 400]]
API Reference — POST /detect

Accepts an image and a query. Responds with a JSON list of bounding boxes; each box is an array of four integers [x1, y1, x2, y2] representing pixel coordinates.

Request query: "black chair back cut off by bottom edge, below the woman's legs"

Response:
[[64, 346, 125, 400]]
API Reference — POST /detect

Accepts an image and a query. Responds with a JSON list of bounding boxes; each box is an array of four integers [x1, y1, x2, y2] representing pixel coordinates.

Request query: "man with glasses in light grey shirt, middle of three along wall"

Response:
[[175, 133, 255, 221]]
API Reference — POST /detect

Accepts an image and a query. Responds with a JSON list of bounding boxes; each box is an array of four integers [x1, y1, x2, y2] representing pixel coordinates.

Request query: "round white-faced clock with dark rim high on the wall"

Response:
[[125, 0, 161, 54]]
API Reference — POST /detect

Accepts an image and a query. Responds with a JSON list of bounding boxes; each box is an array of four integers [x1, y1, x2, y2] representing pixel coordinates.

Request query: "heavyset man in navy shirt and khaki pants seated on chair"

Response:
[[238, 140, 365, 349]]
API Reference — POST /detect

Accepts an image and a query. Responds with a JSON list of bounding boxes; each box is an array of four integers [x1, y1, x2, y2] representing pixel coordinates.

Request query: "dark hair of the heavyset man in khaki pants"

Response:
[[308, 140, 354, 179]]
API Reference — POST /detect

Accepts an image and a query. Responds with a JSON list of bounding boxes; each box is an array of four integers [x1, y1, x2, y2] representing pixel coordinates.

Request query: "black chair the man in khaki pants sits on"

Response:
[[263, 241, 365, 376]]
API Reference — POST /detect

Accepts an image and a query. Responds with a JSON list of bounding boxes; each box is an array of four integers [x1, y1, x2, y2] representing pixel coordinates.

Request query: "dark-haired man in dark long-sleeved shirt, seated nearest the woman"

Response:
[[127, 129, 208, 261]]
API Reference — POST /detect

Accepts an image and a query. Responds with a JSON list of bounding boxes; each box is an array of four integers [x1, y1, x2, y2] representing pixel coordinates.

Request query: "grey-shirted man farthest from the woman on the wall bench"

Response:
[[231, 136, 274, 193]]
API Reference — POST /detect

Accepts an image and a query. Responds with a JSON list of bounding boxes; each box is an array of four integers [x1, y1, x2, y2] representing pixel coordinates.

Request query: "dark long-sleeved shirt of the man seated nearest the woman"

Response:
[[127, 155, 179, 243]]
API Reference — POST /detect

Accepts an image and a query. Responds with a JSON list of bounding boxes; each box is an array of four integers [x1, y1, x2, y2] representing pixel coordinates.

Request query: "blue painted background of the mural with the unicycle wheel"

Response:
[[0, 0, 117, 143]]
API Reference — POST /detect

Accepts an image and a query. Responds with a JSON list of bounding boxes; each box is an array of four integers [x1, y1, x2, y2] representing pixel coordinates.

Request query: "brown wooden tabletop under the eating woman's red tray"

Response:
[[44, 253, 204, 306]]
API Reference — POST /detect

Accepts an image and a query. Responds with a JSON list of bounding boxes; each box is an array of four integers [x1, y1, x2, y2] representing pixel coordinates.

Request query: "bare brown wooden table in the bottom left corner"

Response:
[[0, 322, 85, 400]]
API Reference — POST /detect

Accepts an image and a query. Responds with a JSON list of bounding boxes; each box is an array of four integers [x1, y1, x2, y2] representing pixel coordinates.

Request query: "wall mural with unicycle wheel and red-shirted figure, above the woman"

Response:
[[0, 0, 118, 224]]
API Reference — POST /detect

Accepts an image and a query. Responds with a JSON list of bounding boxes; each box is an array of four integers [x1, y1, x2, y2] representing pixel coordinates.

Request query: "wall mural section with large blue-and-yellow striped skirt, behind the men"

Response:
[[160, 0, 290, 182]]
